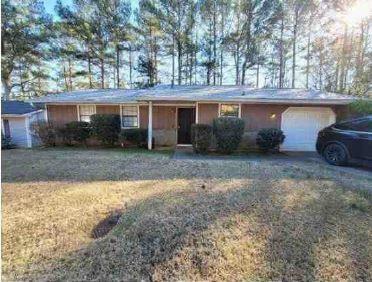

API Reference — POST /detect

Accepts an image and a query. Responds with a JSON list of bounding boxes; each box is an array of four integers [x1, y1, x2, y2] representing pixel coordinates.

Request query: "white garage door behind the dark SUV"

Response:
[[281, 107, 336, 151]]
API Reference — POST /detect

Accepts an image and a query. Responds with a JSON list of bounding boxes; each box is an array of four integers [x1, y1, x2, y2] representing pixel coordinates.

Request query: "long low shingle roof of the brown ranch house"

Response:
[[28, 86, 354, 104]]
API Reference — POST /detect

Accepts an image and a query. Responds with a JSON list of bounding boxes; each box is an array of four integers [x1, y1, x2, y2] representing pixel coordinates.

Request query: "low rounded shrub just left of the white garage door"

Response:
[[256, 128, 285, 152]]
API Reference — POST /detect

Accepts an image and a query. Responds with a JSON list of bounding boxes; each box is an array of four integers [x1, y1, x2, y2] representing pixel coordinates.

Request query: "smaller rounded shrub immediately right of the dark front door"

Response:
[[191, 124, 213, 153]]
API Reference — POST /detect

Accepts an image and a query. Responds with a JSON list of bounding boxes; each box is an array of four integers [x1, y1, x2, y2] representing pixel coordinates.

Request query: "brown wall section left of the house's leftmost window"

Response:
[[47, 105, 78, 125]]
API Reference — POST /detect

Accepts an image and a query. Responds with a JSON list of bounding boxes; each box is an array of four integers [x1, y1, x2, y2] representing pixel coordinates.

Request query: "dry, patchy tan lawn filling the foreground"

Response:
[[2, 148, 372, 281]]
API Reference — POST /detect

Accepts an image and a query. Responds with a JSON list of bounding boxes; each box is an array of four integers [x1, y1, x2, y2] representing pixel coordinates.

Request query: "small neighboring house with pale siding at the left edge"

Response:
[[1, 101, 47, 148]]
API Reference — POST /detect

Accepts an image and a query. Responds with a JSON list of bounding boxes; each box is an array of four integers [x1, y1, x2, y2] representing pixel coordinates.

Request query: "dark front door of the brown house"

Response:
[[177, 108, 195, 144]]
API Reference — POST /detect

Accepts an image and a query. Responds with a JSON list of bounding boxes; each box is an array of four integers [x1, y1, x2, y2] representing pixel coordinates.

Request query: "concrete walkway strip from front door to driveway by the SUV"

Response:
[[172, 147, 372, 180]]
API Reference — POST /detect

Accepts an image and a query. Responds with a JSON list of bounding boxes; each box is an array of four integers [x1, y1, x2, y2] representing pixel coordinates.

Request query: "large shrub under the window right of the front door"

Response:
[[213, 117, 244, 154]]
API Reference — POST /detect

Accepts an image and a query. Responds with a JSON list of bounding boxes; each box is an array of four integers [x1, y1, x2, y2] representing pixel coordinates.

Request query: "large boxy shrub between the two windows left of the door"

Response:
[[90, 114, 120, 146]]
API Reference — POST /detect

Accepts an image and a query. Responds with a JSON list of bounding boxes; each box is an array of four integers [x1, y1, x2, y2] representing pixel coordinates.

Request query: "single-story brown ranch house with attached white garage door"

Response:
[[29, 86, 353, 151]]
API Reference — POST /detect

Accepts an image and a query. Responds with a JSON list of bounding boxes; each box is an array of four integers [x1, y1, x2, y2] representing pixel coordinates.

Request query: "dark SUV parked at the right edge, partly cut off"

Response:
[[316, 115, 372, 165]]
